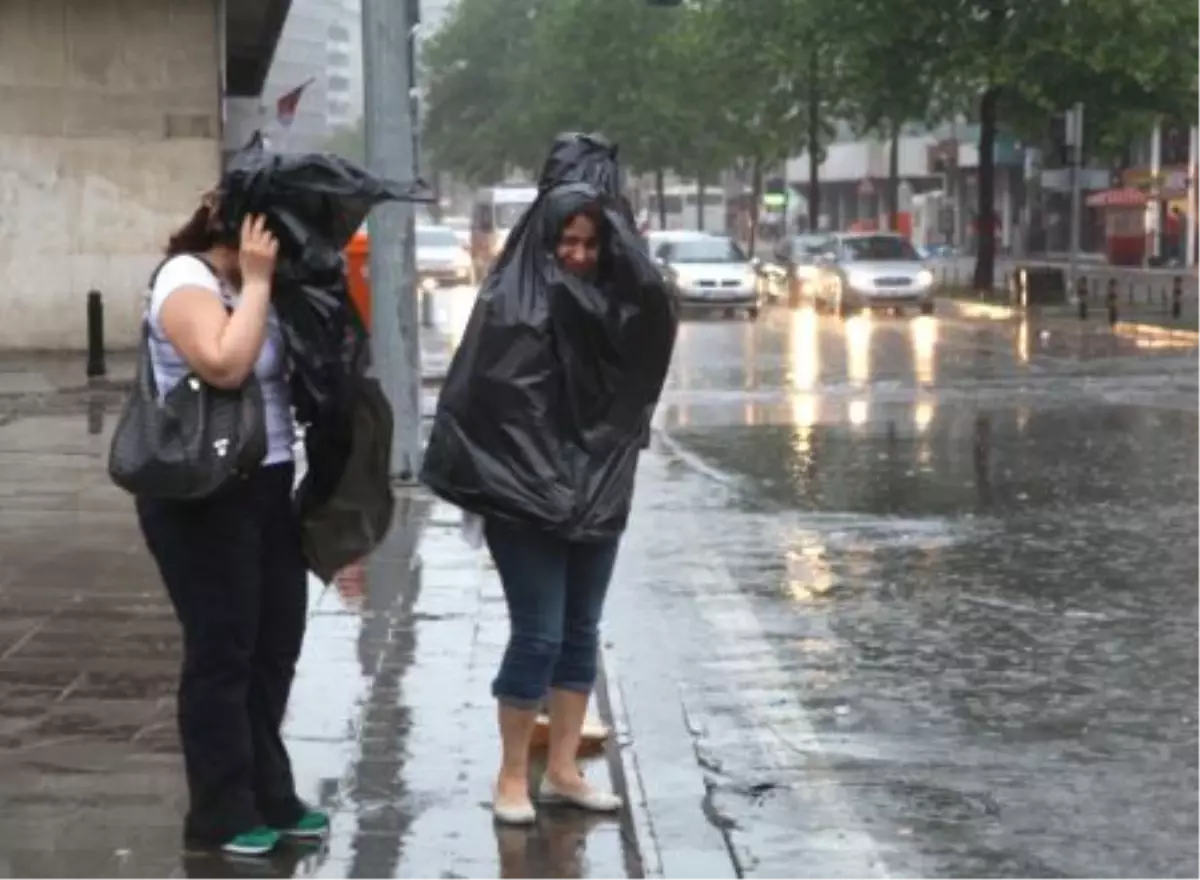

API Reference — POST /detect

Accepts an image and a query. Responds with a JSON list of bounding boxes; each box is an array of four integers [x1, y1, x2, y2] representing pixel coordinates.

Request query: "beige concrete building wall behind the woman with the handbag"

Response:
[[0, 0, 287, 349]]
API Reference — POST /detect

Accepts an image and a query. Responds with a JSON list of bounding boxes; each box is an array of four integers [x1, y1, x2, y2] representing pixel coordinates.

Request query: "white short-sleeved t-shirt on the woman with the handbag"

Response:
[[146, 255, 295, 465]]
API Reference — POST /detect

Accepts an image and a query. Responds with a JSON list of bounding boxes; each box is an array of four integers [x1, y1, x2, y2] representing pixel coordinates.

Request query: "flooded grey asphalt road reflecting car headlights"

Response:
[[606, 298, 1200, 880]]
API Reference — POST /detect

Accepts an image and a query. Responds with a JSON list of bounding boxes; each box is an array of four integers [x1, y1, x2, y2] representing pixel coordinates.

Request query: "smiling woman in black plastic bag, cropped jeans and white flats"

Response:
[[422, 138, 676, 825]]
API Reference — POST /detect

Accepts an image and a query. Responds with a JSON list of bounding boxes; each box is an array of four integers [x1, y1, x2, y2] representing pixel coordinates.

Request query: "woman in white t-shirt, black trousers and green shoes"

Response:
[[137, 196, 329, 855]]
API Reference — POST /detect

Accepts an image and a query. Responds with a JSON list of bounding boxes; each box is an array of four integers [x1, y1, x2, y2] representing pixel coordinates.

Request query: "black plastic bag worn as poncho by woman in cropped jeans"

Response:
[[422, 136, 678, 541]]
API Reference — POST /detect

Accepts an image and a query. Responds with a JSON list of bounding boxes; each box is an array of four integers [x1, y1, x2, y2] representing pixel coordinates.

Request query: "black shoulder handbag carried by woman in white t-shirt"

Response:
[[108, 279, 266, 501]]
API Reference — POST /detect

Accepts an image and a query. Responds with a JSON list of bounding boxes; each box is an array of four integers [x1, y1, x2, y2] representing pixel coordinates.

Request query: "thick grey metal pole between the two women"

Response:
[[362, 0, 421, 484]]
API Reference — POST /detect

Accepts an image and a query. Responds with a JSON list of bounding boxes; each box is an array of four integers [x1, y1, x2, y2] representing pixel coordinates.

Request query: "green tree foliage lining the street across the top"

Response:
[[424, 0, 1200, 274]]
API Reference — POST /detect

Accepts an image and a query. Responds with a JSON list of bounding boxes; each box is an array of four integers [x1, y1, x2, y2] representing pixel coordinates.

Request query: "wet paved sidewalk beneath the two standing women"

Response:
[[0, 409, 636, 880]]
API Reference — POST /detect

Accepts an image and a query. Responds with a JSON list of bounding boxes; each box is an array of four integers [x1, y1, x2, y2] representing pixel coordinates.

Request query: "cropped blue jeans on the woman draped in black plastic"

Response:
[[484, 520, 618, 710]]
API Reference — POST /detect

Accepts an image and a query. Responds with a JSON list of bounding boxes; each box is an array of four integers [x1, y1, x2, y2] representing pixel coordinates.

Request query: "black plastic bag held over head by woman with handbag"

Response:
[[218, 142, 430, 576]]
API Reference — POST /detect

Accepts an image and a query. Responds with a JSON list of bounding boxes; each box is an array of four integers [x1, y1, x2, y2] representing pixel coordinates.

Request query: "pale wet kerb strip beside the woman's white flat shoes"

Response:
[[596, 640, 665, 880]]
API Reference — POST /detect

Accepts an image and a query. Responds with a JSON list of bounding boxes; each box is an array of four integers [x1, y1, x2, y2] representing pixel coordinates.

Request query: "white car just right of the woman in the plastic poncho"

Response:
[[653, 233, 764, 321]]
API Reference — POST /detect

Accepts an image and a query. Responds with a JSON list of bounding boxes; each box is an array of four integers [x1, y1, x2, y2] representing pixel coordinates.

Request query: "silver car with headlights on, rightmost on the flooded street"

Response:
[[814, 233, 934, 316]]
